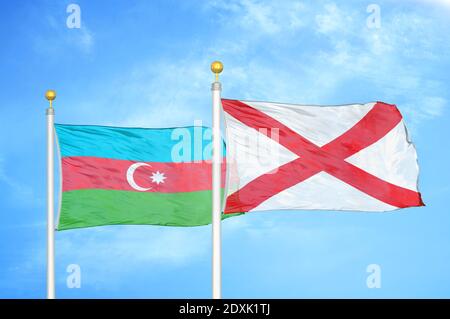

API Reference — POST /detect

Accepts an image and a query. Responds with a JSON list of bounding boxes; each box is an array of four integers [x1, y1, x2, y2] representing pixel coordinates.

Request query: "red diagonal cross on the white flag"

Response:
[[222, 99, 423, 213]]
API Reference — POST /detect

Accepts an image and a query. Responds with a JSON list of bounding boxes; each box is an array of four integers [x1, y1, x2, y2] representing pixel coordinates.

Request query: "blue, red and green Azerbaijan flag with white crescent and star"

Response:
[[55, 124, 237, 230]]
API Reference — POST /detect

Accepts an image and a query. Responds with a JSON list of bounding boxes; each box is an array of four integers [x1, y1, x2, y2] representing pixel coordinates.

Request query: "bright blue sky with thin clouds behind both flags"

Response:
[[0, 0, 450, 298]]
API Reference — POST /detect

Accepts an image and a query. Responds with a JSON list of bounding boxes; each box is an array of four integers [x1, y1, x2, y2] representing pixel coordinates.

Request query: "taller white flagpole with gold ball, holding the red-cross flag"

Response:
[[211, 61, 223, 299]]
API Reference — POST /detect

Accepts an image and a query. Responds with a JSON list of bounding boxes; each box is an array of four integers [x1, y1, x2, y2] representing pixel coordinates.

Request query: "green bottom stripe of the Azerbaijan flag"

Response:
[[58, 189, 240, 230]]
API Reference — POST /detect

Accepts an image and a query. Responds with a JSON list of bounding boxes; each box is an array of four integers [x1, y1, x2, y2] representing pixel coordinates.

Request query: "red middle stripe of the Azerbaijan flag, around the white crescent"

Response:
[[61, 156, 225, 193]]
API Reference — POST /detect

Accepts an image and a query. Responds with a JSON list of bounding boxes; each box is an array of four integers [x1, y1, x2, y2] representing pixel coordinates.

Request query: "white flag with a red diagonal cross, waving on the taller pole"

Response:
[[222, 99, 424, 213]]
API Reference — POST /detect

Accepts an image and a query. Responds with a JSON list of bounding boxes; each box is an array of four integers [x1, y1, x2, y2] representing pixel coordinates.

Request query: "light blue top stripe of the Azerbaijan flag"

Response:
[[55, 124, 225, 162]]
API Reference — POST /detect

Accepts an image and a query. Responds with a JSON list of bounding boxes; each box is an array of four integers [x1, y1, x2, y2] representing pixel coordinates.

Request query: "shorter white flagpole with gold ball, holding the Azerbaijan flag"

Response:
[[45, 90, 56, 299]]
